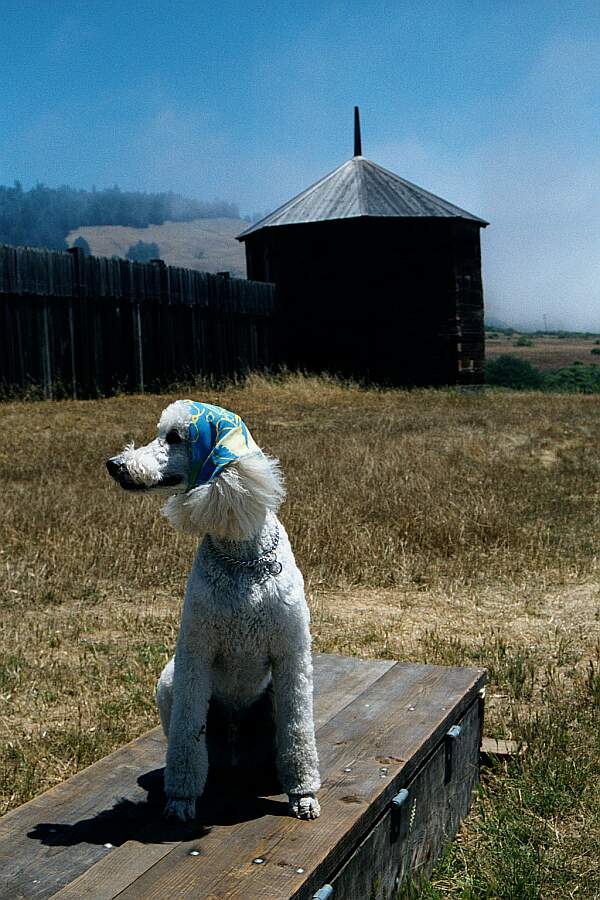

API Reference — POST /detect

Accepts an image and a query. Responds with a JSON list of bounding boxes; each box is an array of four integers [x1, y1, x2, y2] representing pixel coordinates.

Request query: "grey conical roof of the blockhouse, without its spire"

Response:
[[238, 156, 488, 241]]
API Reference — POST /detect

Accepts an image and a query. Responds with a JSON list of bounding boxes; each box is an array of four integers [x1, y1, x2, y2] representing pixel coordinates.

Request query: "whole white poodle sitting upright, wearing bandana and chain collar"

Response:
[[107, 400, 320, 820]]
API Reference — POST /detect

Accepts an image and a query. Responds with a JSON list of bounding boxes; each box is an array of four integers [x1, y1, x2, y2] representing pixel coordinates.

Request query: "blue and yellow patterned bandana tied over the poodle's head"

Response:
[[186, 400, 262, 490]]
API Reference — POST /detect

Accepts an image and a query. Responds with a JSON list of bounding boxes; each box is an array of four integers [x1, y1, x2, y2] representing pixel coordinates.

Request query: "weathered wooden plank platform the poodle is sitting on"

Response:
[[0, 655, 485, 900]]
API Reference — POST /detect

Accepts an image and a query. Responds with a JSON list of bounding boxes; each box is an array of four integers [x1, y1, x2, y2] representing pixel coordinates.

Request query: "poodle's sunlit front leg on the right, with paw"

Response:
[[273, 639, 321, 819]]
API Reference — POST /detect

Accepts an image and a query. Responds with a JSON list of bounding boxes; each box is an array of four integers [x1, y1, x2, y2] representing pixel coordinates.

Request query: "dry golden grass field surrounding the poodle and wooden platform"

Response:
[[0, 377, 600, 900]]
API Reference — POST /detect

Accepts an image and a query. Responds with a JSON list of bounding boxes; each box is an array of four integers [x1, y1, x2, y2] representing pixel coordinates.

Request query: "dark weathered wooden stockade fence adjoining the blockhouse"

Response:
[[0, 246, 275, 397]]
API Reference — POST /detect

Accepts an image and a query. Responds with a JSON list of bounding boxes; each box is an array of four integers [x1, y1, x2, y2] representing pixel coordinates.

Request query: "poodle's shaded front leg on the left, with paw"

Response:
[[165, 642, 211, 821]]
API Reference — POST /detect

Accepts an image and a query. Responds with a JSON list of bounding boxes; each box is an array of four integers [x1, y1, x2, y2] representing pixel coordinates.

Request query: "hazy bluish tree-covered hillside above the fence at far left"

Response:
[[0, 181, 239, 250]]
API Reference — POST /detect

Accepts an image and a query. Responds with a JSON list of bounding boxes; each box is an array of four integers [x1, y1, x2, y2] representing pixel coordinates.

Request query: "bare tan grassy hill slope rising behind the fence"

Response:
[[67, 219, 248, 278]]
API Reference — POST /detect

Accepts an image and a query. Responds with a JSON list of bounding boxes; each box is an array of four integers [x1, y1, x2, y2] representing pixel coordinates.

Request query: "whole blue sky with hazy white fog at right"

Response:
[[0, 0, 600, 331]]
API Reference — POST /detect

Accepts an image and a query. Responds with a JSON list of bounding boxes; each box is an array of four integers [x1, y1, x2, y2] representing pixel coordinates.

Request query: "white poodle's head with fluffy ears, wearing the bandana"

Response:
[[106, 400, 284, 540]]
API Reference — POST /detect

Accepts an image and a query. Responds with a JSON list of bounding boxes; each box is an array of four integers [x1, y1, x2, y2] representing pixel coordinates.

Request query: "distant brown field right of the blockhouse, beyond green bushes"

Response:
[[485, 332, 600, 372]]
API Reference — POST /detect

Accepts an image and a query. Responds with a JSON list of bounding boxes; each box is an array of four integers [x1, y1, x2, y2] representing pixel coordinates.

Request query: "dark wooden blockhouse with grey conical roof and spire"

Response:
[[238, 110, 487, 385]]
